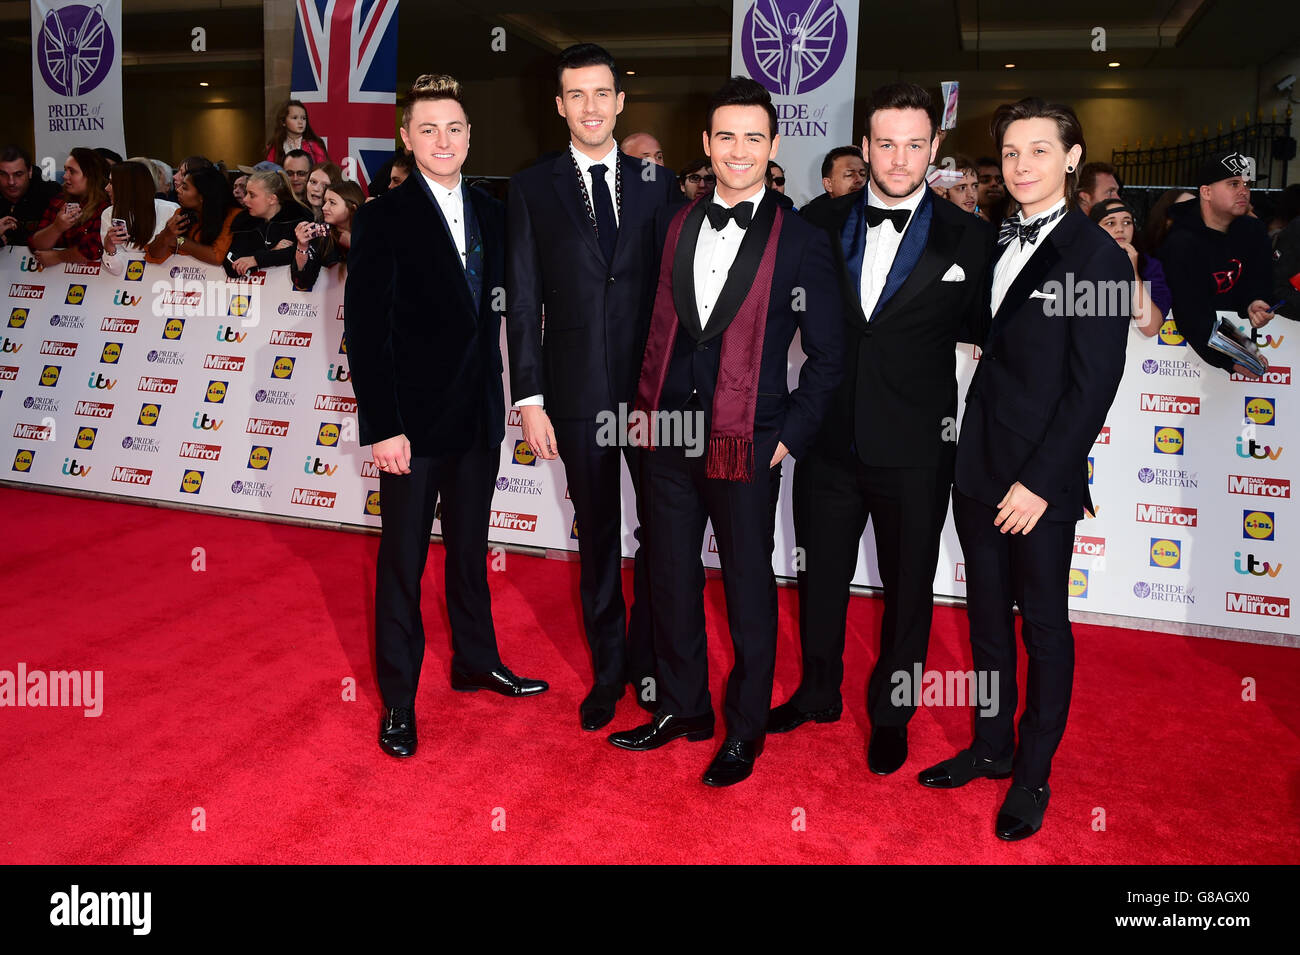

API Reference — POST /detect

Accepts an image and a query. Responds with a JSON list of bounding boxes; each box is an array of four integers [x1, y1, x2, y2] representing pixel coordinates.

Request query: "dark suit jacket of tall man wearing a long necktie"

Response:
[[506, 149, 677, 420]]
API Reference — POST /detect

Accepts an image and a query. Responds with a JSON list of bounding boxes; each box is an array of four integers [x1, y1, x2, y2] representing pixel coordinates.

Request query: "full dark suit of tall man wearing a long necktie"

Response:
[[506, 149, 676, 690]]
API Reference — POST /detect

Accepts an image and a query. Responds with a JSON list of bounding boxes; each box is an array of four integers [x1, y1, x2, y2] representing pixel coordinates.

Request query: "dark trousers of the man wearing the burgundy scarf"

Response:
[[645, 428, 781, 741]]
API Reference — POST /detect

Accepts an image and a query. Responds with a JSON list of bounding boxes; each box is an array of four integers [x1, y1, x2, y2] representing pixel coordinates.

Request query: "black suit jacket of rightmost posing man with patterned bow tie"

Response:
[[956, 210, 1134, 521]]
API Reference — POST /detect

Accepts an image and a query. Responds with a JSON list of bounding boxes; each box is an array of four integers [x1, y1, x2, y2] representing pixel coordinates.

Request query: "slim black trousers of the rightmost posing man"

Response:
[[953, 490, 1075, 789]]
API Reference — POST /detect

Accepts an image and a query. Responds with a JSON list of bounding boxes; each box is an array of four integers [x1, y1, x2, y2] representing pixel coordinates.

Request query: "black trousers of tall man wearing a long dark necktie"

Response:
[[551, 418, 655, 693]]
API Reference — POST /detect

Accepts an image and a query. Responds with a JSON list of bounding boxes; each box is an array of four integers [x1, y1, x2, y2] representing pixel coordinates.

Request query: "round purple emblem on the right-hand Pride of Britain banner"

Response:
[[740, 0, 849, 96]]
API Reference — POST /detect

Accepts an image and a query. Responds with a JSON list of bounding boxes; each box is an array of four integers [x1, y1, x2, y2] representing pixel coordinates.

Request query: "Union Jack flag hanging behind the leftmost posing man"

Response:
[[291, 0, 398, 192]]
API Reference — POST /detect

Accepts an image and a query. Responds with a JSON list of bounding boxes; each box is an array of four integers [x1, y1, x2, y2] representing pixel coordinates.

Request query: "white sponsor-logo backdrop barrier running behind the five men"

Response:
[[0, 248, 1300, 633]]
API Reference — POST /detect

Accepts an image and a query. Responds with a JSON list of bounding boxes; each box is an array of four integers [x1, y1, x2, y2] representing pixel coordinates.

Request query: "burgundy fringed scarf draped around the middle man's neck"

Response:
[[636, 196, 783, 483]]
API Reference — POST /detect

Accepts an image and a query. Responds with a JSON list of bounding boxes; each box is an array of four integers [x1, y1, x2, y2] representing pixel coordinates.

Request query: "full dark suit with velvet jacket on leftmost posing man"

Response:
[[343, 170, 506, 707]]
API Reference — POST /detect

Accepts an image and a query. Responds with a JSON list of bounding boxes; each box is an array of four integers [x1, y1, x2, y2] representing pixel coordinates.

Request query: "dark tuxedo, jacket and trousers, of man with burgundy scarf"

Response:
[[646, 190, 841, 741]]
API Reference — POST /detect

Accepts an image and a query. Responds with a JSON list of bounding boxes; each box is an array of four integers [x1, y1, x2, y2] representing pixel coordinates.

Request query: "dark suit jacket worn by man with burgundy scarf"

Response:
[[654, 190, 844, 465]]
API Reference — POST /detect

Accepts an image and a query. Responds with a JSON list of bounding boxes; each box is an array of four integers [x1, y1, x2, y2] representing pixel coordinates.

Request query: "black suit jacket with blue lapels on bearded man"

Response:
[[801, 190, 995, 468]]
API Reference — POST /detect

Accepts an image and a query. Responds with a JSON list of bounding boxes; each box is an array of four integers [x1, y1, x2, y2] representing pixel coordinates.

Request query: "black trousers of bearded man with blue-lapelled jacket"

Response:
[[790, 452, 953, 726]]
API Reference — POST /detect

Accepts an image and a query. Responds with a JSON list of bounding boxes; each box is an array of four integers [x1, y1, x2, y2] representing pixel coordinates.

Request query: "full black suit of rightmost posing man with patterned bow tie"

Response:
[[953, 210, 1132, 789]]
